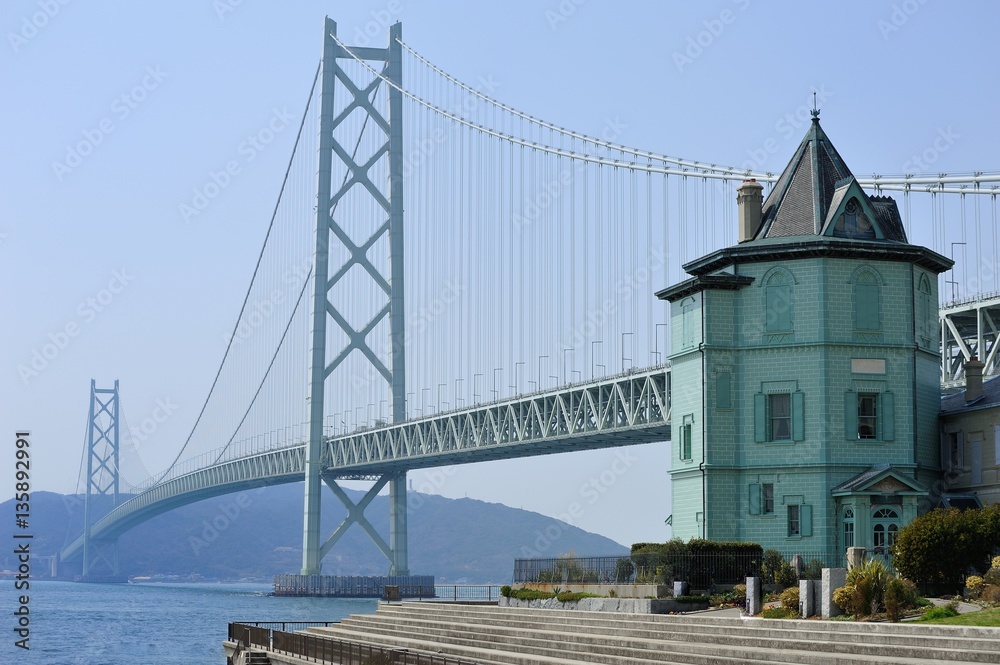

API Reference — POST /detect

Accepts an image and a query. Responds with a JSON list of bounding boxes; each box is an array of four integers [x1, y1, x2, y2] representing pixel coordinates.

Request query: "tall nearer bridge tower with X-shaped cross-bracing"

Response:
[[302, 17, 409, 575]]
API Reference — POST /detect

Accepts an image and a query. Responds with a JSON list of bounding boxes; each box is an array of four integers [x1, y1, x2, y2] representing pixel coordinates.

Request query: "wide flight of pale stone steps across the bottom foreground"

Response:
[[306, 602, 1000, 665]]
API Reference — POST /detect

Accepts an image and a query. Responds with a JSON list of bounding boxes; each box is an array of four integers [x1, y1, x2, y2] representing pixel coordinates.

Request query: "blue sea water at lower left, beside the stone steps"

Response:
[[0, 581, 378, 665]]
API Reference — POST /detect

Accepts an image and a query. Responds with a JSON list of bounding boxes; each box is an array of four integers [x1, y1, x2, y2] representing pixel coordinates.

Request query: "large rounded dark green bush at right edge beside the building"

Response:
[[893, 504, 1000, 593]]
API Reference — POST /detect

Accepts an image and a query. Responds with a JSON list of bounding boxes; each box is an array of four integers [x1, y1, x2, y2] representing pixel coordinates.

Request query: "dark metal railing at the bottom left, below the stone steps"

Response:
[[229, 622, 475, 665]]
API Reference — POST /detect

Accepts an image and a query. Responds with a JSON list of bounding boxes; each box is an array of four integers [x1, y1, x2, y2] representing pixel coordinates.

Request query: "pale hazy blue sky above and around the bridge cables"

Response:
[[0, 0, 1000, 544]]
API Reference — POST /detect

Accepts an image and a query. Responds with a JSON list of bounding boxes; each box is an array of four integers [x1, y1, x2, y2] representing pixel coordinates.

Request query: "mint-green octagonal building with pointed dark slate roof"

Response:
[[657, 113, 952, 554]]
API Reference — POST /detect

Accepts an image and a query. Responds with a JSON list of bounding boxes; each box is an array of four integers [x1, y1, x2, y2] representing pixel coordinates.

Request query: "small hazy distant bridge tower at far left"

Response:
[[83, 379, 120, 579]]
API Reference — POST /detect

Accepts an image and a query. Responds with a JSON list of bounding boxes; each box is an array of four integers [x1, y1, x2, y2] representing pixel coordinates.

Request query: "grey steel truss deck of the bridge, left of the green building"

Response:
[[61, 368, 670, 560]]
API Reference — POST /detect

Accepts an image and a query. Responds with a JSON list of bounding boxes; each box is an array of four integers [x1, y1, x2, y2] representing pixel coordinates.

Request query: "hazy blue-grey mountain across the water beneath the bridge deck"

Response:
[[0, 483, 628, 583]]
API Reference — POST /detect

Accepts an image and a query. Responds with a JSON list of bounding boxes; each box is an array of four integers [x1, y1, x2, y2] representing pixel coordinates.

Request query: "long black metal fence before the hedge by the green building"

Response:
[[514, 552, 844, 589]]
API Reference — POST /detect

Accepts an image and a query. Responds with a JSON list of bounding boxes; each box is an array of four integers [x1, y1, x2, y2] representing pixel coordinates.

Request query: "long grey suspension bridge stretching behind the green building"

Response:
[[60, 19, 1000, 577]]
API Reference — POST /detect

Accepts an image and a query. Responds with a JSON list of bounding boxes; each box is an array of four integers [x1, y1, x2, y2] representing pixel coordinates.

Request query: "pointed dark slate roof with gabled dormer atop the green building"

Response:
[[754, 115, 906, 243]]
